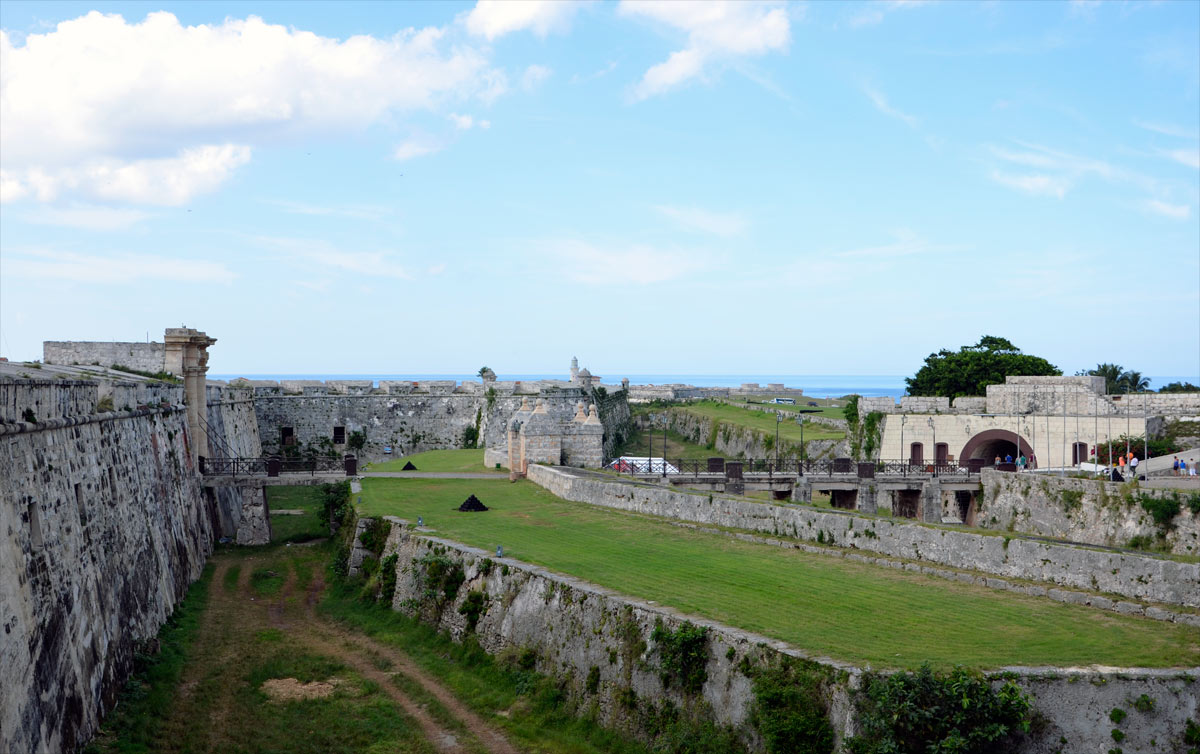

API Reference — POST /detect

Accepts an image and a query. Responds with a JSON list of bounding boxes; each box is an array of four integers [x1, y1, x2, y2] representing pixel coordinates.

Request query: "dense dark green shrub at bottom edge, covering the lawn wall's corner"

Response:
[[846, 665, 1031, 754]]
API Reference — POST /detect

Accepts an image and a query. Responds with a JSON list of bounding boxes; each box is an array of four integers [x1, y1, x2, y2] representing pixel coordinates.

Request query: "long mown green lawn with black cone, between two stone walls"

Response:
[[361, 478, 1200, 668]]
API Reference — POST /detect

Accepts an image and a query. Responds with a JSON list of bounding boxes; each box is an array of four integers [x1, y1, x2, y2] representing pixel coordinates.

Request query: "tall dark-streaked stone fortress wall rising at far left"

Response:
[[0, 382, 212, 753]]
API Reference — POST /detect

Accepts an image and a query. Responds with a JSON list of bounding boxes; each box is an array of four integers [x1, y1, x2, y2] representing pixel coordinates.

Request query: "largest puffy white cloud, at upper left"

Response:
[[0, 12, 508, 204]]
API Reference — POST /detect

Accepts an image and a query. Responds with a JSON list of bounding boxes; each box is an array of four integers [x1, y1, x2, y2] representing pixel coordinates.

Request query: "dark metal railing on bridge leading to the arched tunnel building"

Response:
[[606, 457, 983, 479]]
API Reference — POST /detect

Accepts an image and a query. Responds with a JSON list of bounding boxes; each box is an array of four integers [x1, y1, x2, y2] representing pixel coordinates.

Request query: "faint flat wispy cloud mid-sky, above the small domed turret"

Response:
[[540, 239, 707, 285]]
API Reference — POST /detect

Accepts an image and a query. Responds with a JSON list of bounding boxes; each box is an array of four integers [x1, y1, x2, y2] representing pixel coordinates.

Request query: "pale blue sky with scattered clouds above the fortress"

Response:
[[0, 0, 1200, 377]]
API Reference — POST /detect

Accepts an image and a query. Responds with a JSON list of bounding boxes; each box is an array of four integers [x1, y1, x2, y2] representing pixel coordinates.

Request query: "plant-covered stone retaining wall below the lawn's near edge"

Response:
[[372, 517, 1200, 754]]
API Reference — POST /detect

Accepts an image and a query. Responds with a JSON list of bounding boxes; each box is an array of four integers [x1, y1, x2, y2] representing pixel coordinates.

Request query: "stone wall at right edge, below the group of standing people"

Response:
[[976, 468, 1200, 557]]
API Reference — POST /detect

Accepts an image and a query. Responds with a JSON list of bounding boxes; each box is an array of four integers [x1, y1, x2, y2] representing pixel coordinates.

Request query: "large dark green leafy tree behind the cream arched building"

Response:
[[905, 335, 1062, 399]]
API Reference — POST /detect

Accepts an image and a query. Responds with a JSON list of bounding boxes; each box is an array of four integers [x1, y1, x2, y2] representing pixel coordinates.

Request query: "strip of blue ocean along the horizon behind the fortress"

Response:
[[209, 372, 905, 397]]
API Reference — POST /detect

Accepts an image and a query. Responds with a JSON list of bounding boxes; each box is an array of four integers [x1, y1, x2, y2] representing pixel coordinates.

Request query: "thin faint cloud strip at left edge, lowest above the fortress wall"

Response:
[[5, 250, 235, 283]]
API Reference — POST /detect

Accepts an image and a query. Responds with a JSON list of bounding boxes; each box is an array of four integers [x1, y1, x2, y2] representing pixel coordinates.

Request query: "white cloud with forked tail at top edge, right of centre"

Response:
[[618, 0, 791, 100]]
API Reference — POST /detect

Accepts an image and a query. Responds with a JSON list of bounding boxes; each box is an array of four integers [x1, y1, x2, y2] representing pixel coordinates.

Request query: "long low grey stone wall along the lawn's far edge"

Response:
[[528, 466, 1200, 608]]
